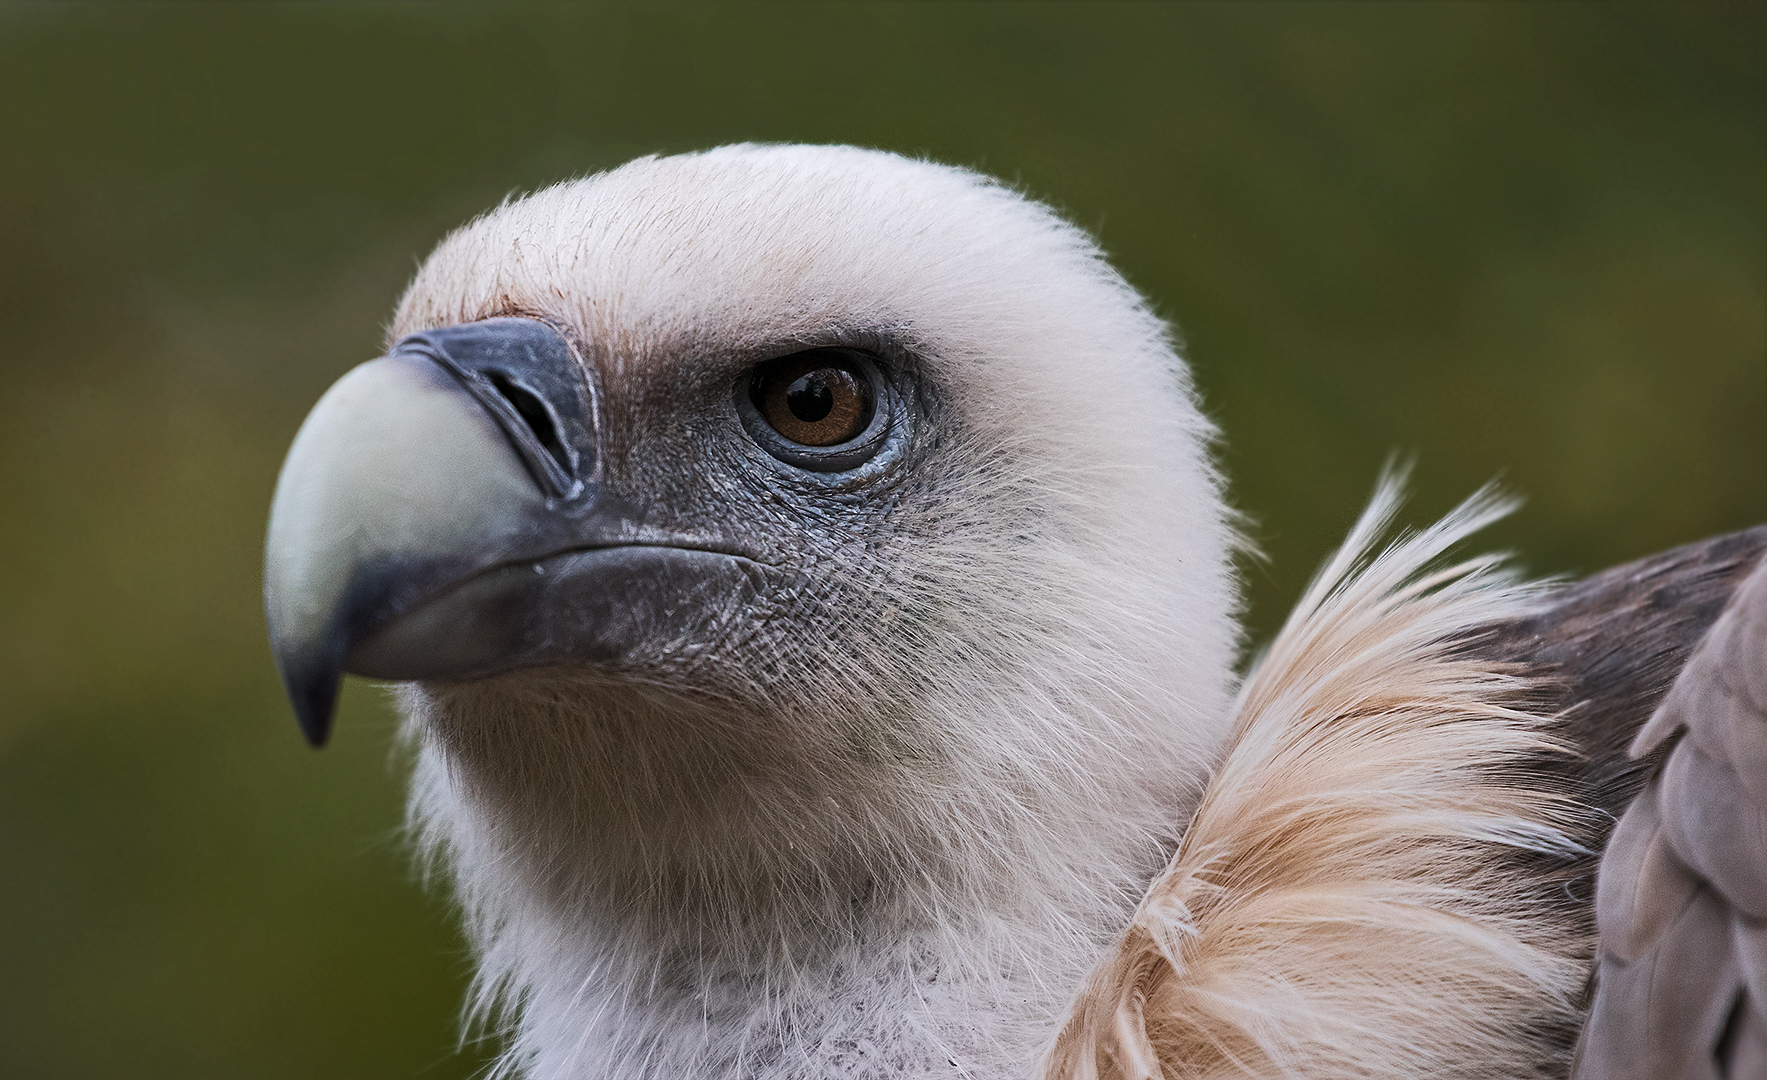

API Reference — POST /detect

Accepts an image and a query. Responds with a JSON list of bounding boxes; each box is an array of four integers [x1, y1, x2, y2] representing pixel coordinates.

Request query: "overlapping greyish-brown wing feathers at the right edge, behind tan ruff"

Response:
[[1576, 562, 1767, 1080]]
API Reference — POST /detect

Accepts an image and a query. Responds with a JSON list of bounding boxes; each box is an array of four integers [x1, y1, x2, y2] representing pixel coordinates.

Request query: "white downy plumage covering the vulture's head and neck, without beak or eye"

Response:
[[392, 147, 1237, 1078]]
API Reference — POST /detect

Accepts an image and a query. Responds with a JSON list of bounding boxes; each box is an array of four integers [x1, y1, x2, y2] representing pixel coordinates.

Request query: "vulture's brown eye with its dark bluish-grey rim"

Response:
[[735, 348, 894, 472]]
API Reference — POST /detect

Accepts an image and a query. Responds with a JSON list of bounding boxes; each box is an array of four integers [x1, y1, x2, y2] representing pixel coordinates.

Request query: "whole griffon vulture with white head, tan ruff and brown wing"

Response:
[[265, 145, 1767, 1080]]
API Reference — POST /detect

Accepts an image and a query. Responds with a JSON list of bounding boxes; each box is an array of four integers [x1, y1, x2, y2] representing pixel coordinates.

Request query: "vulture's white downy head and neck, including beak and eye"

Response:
[[265, 147, 1239, 1078]]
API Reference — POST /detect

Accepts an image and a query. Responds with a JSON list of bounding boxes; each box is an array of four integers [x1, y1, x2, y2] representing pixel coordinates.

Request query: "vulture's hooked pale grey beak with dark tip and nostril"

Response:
[[263, 318, 760, 746]]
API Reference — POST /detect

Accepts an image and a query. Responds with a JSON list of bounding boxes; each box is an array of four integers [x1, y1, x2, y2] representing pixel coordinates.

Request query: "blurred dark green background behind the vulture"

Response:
[[0, 4, 1767, 1080]]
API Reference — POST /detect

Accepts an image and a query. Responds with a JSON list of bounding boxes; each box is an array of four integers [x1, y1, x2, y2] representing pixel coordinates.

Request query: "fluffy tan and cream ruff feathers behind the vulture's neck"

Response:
[[1044, 479, 1589, 1080]]
